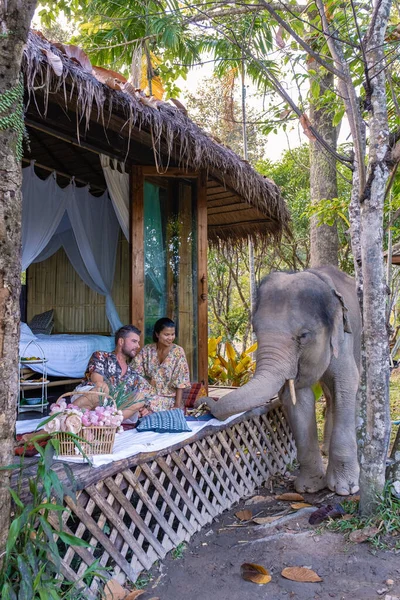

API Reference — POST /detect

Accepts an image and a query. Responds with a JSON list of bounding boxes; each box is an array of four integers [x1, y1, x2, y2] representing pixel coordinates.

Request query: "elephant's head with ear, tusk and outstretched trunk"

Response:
[[208, 267, 358, 419]]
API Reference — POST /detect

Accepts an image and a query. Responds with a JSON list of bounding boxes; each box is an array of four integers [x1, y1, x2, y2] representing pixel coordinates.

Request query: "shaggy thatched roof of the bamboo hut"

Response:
[[23, 32, 290, 242]]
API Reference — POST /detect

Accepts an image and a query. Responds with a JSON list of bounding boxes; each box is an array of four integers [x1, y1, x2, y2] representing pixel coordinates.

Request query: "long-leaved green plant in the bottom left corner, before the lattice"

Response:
[[0, 433, 105, 600]]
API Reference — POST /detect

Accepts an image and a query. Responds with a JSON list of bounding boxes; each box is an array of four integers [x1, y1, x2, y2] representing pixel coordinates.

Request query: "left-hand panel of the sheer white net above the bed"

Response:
[[22, 162, 68, 271]]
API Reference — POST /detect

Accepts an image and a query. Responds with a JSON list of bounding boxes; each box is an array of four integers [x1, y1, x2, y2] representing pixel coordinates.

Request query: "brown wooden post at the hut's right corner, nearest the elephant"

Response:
[[197, 171, 208, 388]]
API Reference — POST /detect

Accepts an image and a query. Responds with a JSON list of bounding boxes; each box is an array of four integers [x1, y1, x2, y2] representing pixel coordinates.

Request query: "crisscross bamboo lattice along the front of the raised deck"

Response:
[[43, 401, 296, 598]]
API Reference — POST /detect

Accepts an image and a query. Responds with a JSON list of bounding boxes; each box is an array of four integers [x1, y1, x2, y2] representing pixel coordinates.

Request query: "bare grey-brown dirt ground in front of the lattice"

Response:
[[140, 476, 400, 600]]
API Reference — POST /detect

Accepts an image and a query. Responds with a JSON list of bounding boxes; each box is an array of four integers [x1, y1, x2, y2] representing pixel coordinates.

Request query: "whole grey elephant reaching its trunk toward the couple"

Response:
[[207, 266, 361, 495]]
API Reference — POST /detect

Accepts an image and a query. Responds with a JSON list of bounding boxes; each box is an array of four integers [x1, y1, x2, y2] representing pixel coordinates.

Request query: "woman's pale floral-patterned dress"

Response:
[[132, 344, 190, 411]]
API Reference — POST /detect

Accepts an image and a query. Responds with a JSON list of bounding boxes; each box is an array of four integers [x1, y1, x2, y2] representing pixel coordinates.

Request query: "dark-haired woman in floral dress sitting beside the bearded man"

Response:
[[133, 317, 190, 411]]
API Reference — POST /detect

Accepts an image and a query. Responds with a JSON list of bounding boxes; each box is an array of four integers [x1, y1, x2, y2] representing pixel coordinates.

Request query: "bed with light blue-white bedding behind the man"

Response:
[[19, 323, 115, 378]]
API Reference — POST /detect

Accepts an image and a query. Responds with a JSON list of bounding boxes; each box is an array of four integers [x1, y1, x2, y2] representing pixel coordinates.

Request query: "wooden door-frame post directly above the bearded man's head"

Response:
[[130, 166, 144, 345]]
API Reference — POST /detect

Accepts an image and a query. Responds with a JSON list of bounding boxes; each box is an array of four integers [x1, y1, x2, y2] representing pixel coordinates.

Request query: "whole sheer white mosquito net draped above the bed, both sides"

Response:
[[22, 165, 122, 331]]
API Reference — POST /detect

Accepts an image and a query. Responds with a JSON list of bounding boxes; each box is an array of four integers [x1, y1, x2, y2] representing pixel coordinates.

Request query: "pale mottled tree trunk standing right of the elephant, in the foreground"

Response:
[[360, 0, 391, 515]]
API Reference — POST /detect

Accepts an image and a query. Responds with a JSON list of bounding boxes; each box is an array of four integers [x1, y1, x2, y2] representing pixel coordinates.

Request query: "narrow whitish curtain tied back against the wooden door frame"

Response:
[[100, 154, 129, 242]]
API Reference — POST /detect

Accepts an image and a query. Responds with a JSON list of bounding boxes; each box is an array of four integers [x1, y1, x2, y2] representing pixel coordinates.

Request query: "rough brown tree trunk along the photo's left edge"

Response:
[[0, 0, 36, 555]]
